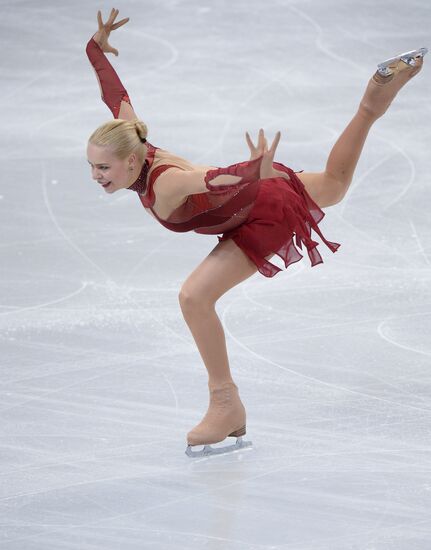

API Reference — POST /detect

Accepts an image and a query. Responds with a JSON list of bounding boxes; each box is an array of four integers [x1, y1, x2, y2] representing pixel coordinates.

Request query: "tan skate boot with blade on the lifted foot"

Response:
[[359, 48, 428, 119]]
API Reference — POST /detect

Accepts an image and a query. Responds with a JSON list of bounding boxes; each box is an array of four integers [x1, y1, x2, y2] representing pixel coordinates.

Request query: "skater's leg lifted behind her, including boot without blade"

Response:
[[298, 58, 423, 207]]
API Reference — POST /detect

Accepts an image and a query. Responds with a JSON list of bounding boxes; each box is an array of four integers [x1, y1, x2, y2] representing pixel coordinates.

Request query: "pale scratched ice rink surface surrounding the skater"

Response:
[[0, 0, 431, 550]]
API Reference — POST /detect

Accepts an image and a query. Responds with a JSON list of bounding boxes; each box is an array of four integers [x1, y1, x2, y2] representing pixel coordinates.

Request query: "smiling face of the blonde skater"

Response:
[[87, 143, 136, 193]]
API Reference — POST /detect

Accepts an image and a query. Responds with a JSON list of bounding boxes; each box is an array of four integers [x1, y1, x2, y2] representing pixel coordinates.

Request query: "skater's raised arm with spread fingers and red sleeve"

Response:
[[86, 9, 138, 120]]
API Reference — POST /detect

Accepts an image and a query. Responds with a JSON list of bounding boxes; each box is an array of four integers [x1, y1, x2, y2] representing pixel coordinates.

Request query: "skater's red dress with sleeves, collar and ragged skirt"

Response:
[[86, 38, 340, 277]]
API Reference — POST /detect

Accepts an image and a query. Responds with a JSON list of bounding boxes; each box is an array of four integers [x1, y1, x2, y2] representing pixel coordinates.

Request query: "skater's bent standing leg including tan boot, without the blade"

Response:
[[179, 239, 272, 445]]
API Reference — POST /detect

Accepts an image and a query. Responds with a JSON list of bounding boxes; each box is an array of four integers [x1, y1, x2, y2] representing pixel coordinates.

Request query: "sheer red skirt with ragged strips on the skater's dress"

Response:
[[217, 163, 341, 277]]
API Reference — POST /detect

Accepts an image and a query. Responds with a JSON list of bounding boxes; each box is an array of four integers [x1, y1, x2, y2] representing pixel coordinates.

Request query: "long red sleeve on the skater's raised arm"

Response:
[[85, 38, 132, 118]]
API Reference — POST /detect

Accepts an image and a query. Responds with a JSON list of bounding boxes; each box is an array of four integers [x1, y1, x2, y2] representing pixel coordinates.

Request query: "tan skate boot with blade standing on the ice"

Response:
[[186, 382, 252, 457]]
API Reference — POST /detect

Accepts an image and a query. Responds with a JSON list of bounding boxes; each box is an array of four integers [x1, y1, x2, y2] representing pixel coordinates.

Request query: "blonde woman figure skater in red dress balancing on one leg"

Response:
[[86, 9, 427, 456]]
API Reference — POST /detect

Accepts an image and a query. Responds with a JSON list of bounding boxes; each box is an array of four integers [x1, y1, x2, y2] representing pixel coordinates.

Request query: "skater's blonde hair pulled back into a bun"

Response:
[[88, 118, 148, 162]]
